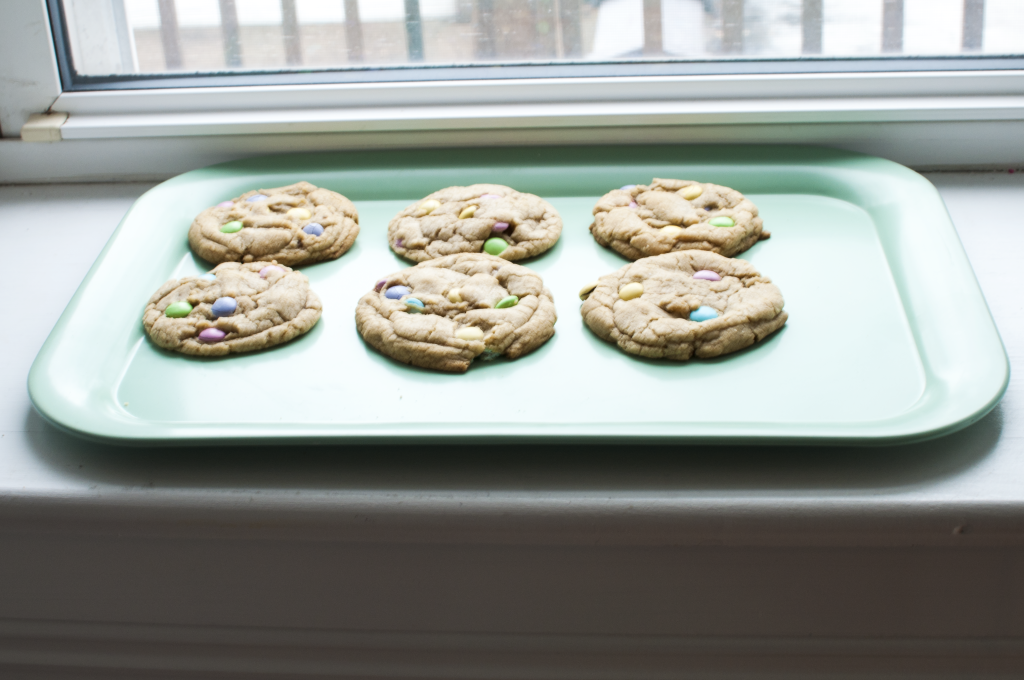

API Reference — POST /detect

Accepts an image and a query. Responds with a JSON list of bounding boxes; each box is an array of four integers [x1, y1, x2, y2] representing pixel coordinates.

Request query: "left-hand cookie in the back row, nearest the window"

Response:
[[188, 182, 359, 266]]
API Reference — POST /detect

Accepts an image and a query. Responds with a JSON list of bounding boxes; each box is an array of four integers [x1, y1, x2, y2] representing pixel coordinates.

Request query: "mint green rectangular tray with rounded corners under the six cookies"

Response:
[[29, 146, 1010, 443]]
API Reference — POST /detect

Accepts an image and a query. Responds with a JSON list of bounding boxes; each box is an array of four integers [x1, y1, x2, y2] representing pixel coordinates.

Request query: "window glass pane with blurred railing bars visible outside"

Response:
[[60, 0, 1024, 77]]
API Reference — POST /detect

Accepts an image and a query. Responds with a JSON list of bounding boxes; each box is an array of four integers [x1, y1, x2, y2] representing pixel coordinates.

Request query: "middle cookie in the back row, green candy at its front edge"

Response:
[[387, 184, 562, 262]]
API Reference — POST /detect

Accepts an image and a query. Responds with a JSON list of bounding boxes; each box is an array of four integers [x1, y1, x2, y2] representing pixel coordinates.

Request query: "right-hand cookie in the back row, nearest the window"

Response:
[[590, 179, 771, 260]]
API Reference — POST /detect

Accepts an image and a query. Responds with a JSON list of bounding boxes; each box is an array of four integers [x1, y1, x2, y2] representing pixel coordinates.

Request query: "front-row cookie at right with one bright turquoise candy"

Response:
[[580, 250, 788, 360]]
